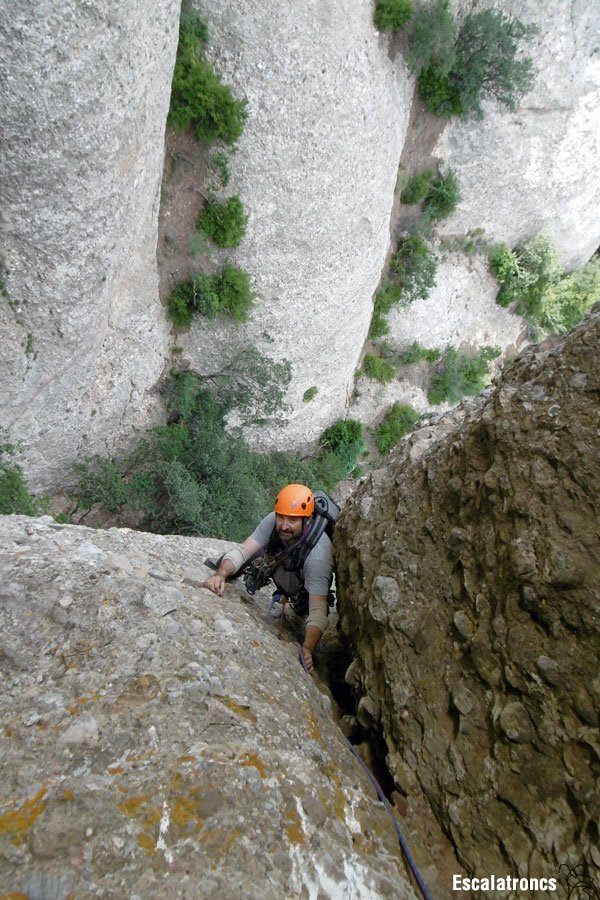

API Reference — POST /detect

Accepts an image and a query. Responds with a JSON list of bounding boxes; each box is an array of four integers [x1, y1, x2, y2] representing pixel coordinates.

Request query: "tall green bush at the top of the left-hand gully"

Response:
[[167, 11, 247, 145]]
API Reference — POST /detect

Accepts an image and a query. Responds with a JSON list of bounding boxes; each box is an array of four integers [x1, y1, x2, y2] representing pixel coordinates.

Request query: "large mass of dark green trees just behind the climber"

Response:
[[76, 371, 364, 541]]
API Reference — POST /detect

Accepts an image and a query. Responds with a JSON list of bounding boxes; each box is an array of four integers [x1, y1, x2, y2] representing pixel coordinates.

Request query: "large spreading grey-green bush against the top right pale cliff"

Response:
[[409, 2, 536, 119]]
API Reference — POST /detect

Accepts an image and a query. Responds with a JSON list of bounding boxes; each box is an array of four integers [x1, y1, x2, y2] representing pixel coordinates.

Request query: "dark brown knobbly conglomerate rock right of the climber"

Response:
[[336, 307, 600, 884]]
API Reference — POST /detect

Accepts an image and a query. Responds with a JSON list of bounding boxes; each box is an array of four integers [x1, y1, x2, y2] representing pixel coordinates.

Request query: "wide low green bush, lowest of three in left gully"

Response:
[[167, 261, 256, 328]]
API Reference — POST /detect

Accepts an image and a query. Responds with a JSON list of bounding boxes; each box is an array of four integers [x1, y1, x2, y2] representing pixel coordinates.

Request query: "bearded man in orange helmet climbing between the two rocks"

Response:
[[205, 484, 333, 672]]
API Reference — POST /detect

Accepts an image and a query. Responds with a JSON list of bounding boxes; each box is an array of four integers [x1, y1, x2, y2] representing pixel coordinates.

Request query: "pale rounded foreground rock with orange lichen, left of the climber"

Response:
[[0, 517, 415, 900]]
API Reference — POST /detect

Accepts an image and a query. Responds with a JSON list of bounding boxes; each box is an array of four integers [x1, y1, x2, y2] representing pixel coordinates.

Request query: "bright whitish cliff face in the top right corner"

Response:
[[433, 0, 600, 268]]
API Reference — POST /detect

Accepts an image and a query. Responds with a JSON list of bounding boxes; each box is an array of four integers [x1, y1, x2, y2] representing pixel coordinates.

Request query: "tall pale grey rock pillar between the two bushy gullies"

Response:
[[186, 0, 412, 448]]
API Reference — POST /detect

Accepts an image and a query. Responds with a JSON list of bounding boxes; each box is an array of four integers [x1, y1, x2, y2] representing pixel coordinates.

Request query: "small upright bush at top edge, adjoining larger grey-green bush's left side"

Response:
[[406, 0, 458, 76]]
